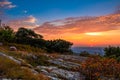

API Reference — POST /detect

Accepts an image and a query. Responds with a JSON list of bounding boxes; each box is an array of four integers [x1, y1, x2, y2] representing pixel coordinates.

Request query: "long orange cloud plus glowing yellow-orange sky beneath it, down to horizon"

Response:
[[34, 14, 120, 46]]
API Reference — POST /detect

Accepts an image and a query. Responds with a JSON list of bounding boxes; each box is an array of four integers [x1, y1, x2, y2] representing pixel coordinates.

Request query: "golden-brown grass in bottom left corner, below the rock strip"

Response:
[[0, 56, 49, 80]]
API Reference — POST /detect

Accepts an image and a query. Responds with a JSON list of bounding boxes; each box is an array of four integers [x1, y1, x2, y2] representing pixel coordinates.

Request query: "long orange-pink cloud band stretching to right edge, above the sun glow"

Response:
[[35, 14, 120, 35]]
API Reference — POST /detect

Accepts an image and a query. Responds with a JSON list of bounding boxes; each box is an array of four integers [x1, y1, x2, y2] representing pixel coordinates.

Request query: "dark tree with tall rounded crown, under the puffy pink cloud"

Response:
[[15, 28, 45, 48]]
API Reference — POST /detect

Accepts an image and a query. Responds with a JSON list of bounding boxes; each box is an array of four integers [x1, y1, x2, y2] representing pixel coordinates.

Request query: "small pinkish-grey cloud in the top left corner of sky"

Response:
[[0, 0, 16, 9]]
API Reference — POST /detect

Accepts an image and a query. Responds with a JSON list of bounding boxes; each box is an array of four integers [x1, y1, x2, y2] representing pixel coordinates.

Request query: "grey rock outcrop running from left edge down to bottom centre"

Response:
[[0, 53, 85, 80]]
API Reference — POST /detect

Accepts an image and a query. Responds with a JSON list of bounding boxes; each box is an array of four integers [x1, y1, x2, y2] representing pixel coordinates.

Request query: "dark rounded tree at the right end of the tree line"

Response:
[[46, 39, 72, 53]]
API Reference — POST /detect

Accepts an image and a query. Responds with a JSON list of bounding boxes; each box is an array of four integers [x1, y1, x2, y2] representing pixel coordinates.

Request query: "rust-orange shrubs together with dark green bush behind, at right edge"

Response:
[[80, 46, 120, 80]]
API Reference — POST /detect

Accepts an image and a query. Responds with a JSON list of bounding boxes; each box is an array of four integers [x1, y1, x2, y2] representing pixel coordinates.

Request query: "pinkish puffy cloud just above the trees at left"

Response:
[[8, 15, 37, 30]]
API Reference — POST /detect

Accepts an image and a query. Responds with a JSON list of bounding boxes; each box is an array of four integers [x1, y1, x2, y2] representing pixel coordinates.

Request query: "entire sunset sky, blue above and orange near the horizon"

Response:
[[0, 0, 120, 47]]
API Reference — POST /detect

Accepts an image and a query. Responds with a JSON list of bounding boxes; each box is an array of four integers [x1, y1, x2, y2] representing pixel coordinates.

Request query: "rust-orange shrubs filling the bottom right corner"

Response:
[[80, 56, 120, 80]]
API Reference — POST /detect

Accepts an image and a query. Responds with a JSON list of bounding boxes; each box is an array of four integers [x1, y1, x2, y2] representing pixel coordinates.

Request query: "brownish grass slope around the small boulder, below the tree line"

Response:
[[0, 43, 52, 66]]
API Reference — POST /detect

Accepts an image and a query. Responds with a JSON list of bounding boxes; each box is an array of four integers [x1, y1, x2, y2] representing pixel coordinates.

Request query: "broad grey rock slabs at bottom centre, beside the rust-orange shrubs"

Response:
[[37, 55, 86, 80]]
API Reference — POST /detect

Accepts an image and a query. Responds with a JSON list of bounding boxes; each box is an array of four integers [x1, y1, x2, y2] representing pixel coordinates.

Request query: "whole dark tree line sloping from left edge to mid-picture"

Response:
[[0, 26, 73, 53]]
